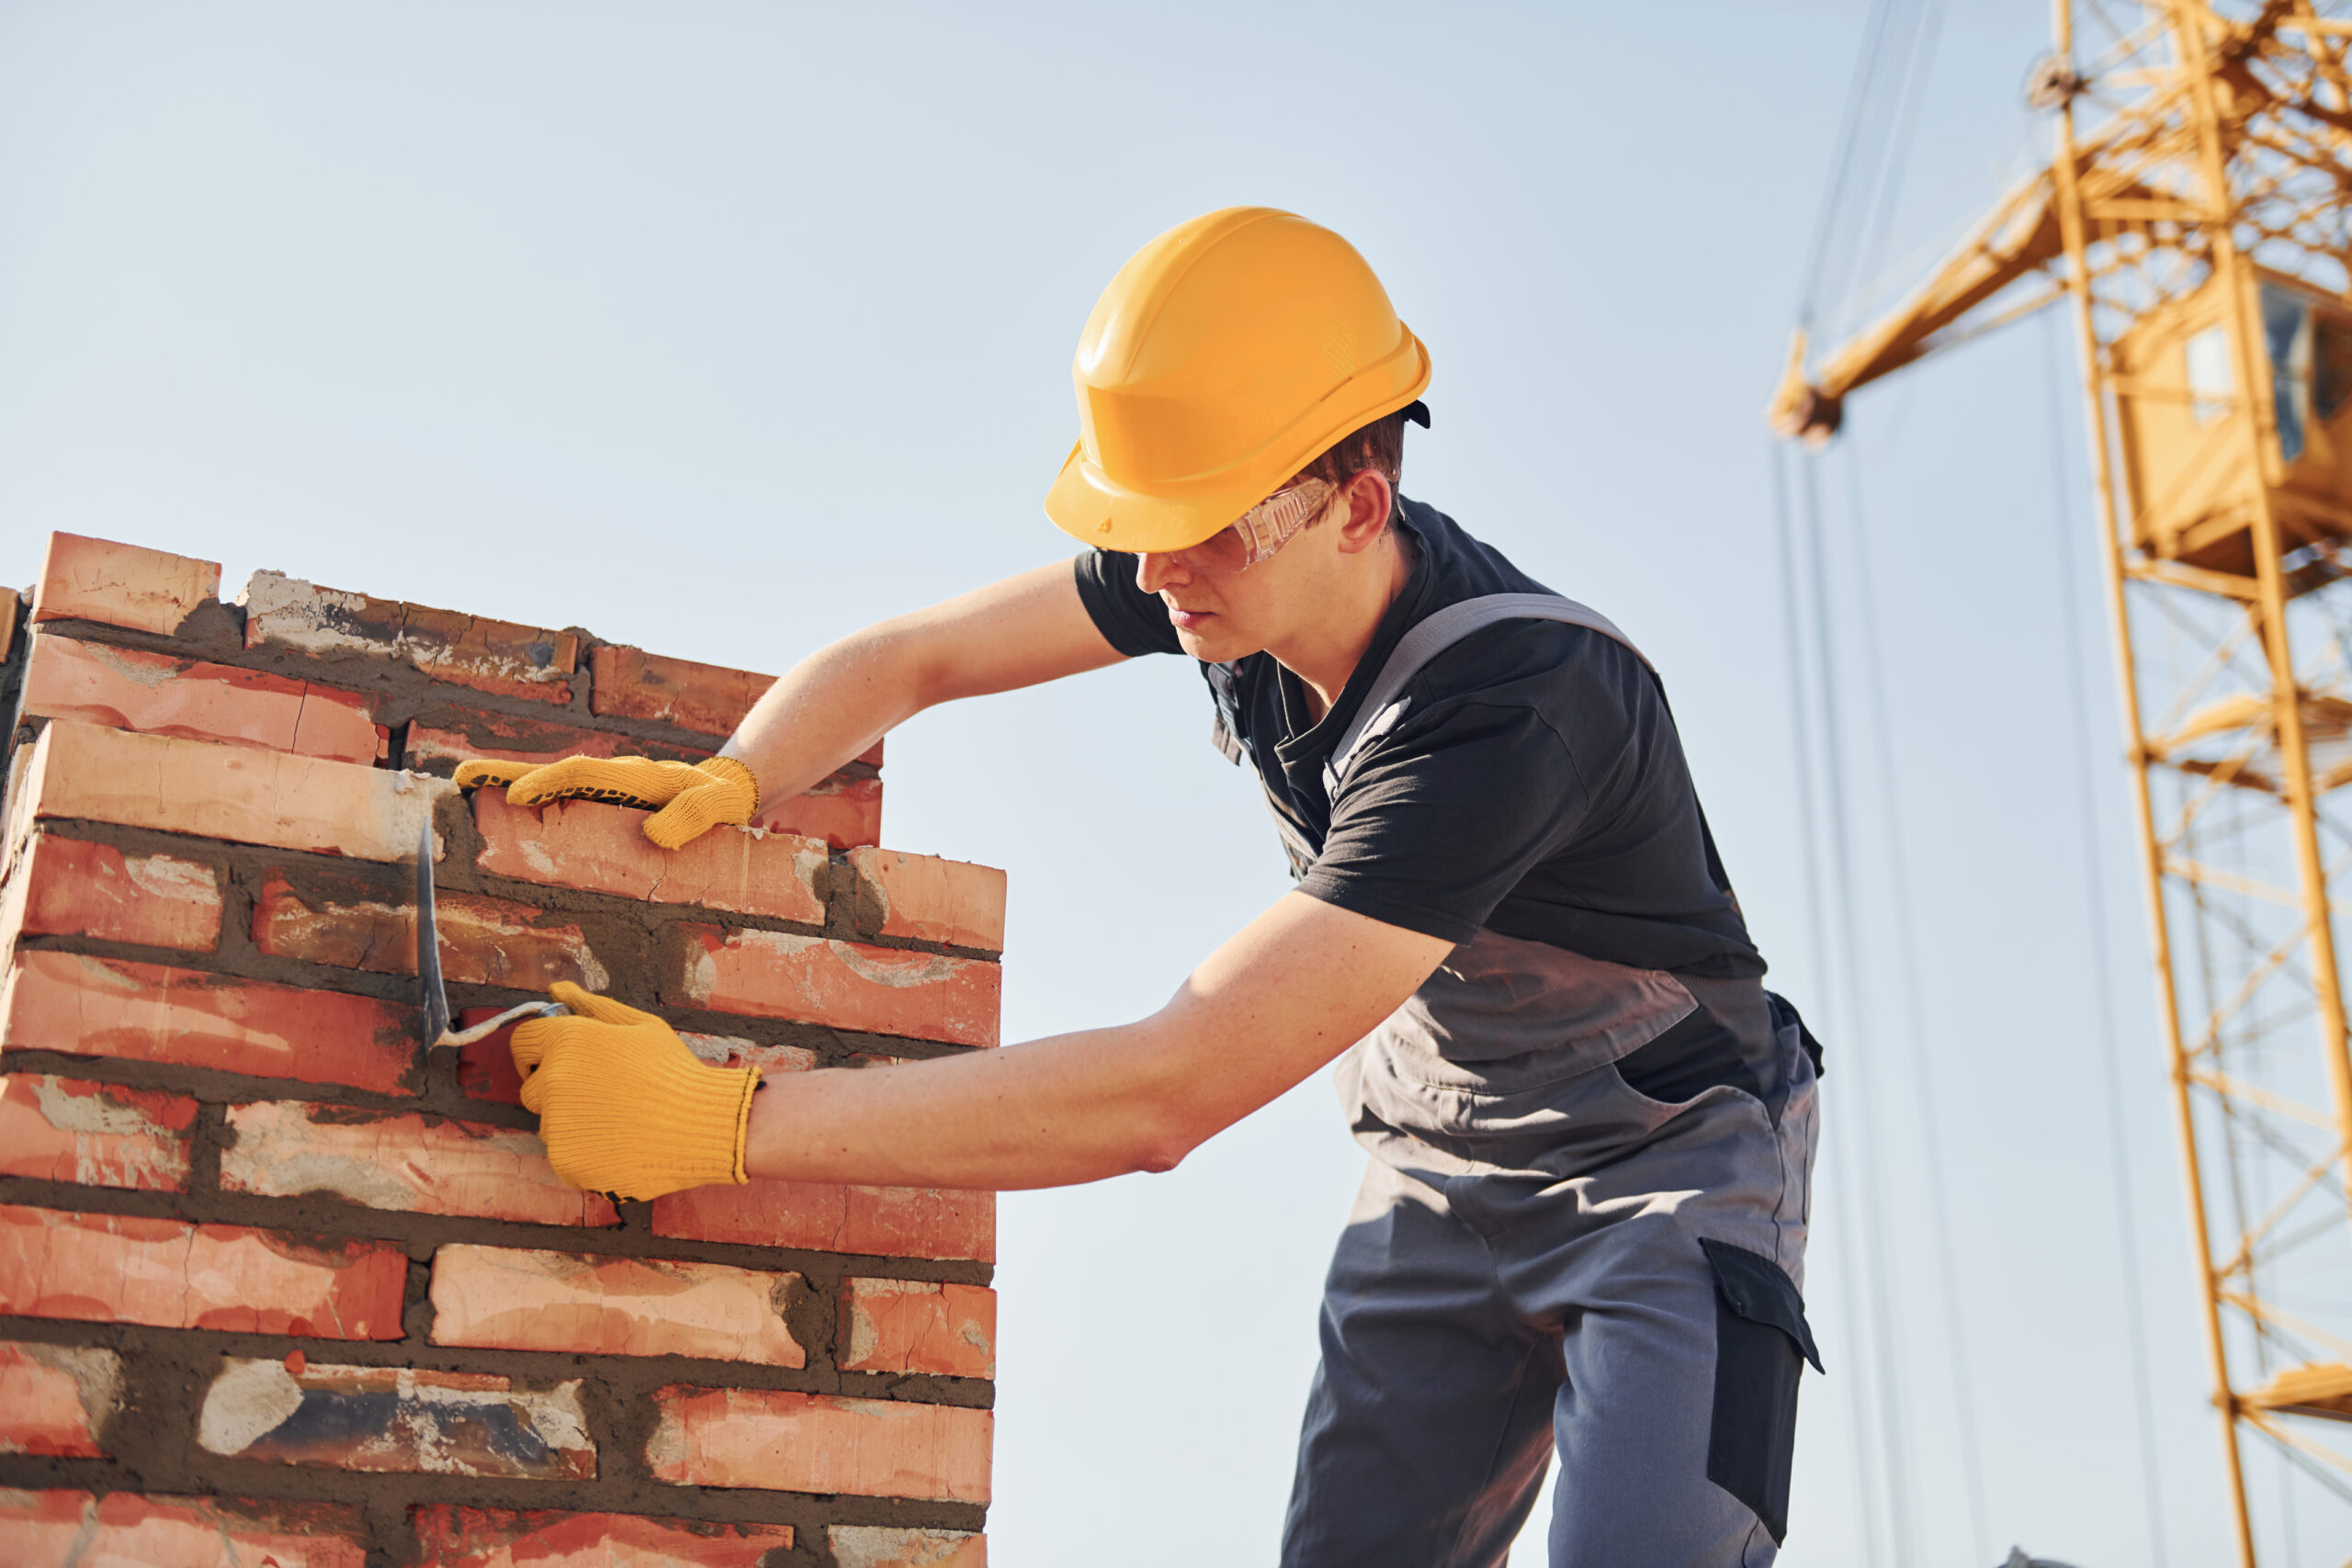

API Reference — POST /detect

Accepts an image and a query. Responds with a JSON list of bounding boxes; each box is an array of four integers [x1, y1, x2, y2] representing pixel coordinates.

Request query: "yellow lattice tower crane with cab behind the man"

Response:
[[1771, 0, 2352, 1568]]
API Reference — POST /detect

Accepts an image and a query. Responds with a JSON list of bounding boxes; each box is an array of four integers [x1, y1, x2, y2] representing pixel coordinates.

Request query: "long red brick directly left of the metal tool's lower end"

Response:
[[0, 952, 416, 1093]]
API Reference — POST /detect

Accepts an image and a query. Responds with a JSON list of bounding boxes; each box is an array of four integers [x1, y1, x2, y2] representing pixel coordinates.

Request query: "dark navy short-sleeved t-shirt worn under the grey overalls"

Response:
[[1075, 499, 1764, 1098]]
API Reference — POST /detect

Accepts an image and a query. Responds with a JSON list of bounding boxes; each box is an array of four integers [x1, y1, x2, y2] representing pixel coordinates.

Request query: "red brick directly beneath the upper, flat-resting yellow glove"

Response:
[[473, 790, 826, 926]]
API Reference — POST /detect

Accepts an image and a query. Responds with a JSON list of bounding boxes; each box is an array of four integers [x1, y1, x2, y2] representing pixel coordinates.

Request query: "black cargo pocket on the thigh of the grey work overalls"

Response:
[[1698, 1239, 1820, 1544]]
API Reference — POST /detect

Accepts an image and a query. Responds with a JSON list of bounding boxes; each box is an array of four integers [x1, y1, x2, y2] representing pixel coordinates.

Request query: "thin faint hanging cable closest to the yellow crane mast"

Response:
[[2041, 315, 2166, 1568]]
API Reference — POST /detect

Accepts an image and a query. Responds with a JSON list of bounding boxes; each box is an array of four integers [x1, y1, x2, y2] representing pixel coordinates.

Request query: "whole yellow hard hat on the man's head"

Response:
[[1045, 207, 1430, 552]]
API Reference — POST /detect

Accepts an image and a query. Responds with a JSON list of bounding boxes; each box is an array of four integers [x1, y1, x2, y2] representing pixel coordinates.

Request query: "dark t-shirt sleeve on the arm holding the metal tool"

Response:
[[1298, 698, 1595, 942]]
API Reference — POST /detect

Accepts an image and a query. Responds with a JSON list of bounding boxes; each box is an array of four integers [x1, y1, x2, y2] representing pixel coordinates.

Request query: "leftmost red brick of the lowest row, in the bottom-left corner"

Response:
[[0, 1491, 367, 1568]]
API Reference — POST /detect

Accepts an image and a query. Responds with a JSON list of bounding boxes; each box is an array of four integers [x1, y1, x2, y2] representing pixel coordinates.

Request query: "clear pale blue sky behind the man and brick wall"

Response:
[[0, 0, 2340, 1568]]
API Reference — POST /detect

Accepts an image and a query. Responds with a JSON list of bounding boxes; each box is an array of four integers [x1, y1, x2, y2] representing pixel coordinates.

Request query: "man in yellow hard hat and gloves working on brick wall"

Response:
[[458, 207, 1818, 1568]]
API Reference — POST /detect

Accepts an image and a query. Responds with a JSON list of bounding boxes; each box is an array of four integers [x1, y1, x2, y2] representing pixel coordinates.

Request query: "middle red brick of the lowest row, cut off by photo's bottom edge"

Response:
[[409, 1505, 795, 1568]]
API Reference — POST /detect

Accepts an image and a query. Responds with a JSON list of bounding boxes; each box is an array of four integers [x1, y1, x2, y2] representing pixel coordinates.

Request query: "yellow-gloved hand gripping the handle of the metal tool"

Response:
[[515, 980, 760, 1201]]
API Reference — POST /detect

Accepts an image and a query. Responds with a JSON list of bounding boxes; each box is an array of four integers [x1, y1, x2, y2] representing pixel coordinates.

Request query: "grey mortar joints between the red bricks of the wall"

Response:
[[0, 602, 995, 1568]]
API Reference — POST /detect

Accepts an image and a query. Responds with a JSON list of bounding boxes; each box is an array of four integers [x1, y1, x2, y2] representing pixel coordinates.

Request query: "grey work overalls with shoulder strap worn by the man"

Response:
[[1211, 594, 1820, 1568]]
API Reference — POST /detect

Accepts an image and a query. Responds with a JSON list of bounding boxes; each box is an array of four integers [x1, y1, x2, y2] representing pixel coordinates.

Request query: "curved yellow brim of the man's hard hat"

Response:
[[1045, 322, 1430, 555]]
